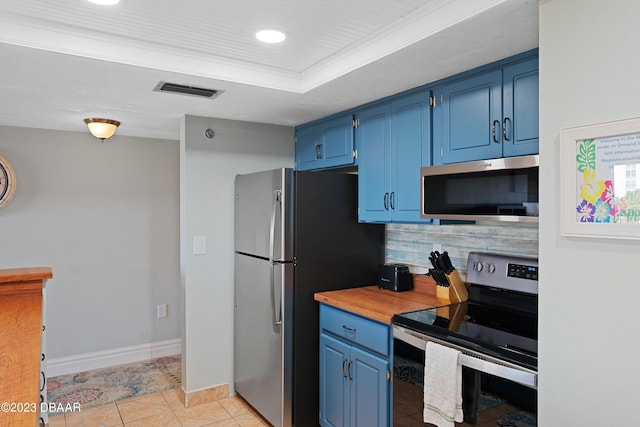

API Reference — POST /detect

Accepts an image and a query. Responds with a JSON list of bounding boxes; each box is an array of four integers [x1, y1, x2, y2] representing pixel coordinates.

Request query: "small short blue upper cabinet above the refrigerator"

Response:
[[295, 114, 355, 170]]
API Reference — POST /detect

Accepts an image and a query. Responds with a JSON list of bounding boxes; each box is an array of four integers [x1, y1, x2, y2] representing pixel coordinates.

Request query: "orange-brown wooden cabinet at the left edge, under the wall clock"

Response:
[[0, 267, 53, 427]]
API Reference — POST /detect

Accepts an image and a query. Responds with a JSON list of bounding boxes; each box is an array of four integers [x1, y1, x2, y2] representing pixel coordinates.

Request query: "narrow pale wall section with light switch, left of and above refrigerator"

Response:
[[180, 116, 293, 392]]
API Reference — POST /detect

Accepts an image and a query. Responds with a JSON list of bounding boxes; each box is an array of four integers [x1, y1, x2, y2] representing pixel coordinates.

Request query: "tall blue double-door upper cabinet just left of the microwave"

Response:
[[356, 90, 431, 223]]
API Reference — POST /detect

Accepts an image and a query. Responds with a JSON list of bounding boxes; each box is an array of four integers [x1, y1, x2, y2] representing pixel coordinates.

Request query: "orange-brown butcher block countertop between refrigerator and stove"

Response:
[[314, 275, 438, 324]]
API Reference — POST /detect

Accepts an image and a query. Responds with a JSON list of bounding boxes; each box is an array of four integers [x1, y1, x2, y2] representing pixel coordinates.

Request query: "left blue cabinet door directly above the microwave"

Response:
[[433, 70, 502, 164]]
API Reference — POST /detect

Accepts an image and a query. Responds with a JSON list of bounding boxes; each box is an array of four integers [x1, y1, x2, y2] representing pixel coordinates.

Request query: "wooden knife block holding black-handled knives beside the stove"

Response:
[[429, 251, 469, 305]]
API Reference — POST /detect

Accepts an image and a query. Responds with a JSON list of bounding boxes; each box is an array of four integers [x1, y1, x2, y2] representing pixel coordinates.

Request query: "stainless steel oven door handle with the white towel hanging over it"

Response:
[[393, 325, 538, 390]]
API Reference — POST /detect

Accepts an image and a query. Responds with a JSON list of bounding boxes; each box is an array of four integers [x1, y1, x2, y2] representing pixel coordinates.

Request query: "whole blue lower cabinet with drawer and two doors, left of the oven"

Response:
[[320, 304, 391, 427]]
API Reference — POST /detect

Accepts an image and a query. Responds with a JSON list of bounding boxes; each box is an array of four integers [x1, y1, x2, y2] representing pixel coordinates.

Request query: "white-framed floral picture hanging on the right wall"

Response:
[[560, 118, 640, 239]]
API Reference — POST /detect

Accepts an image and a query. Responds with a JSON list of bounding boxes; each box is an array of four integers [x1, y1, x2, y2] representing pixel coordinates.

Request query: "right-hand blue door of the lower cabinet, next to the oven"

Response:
[[349, 347, 391, 427]]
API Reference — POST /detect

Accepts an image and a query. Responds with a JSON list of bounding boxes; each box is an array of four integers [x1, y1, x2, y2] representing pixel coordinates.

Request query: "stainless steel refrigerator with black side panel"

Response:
[[234, 168, 384, 427]]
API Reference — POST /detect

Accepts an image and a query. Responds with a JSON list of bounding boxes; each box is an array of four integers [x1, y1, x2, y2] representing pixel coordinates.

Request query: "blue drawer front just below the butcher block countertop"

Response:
[[320, 304, 389, 356]]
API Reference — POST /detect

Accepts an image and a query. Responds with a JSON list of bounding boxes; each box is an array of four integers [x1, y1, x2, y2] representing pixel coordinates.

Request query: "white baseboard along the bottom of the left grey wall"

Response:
[[47, 338, 182, 378]]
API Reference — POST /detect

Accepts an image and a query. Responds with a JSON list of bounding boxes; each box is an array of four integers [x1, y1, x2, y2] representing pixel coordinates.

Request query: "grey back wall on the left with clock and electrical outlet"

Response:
[[0, 127, 182, 360]]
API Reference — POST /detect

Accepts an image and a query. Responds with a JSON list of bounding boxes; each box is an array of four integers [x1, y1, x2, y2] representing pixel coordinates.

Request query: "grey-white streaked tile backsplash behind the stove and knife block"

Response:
[[385, 222, 538, 277]]
